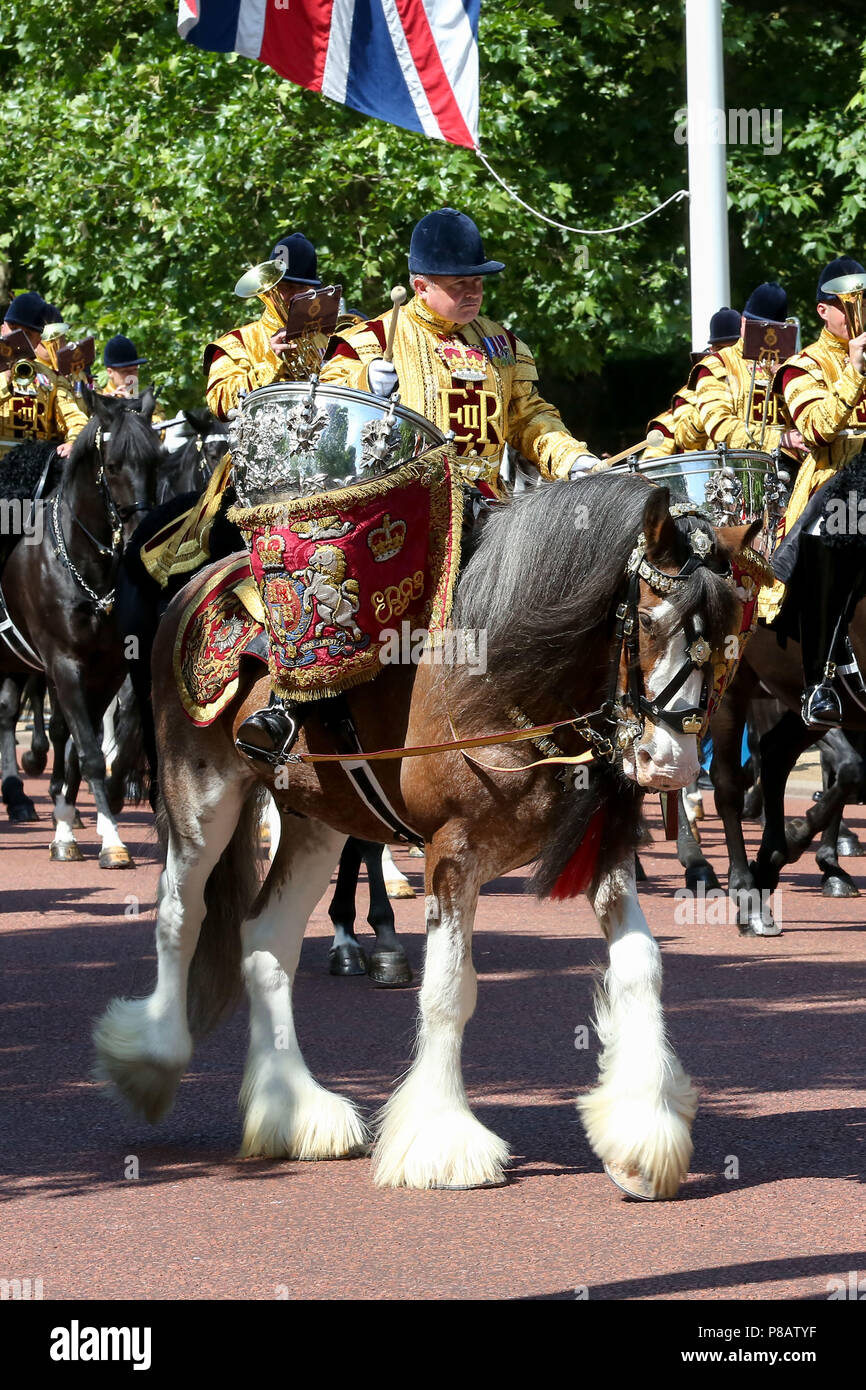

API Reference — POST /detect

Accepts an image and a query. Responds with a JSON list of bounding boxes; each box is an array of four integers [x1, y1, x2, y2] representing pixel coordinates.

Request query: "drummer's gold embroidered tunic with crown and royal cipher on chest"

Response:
[[321, 296, 589, 496]]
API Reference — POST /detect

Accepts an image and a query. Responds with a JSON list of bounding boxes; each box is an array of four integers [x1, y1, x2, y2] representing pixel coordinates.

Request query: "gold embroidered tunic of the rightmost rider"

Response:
[[760, 328, 866, 621]]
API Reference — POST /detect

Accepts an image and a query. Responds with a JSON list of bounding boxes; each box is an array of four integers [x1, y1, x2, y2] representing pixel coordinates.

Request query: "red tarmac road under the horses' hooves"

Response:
[[0, 780, 866, 1300]]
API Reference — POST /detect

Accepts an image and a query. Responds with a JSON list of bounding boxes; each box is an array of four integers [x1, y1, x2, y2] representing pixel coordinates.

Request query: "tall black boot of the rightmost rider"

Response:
[[798, 535, 862, 730]]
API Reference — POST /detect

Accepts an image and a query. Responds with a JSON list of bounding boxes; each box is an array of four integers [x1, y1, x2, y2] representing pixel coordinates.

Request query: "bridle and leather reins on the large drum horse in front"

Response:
[[286, 503, 712, 776]]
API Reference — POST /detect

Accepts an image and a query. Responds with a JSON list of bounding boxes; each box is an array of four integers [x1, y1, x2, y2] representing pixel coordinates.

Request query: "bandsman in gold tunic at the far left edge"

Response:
[[0, 292, 88, 459]]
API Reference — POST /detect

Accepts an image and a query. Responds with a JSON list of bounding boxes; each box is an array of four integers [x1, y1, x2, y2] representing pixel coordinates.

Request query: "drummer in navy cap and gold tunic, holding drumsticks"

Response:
[[321, 207, 599, 496]]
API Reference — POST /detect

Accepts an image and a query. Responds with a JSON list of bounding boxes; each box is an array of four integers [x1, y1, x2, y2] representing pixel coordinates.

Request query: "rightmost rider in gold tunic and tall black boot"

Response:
[[762, 256, 866, 728]]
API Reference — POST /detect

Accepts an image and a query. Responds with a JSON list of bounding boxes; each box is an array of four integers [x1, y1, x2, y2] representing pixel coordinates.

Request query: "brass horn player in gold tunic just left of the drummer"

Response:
[[204, 232, 328, 420]]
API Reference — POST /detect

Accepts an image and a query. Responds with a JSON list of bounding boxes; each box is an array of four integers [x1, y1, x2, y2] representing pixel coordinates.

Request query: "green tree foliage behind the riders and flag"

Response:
[[0, 0, 866, 442]]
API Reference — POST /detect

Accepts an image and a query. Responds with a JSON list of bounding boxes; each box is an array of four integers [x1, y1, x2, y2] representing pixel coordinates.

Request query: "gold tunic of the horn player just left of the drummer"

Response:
[[204, 304, 328, 420]]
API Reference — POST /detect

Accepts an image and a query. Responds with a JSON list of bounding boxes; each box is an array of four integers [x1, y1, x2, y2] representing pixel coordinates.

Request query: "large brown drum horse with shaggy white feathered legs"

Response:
[[95, 477, 746, 1198]]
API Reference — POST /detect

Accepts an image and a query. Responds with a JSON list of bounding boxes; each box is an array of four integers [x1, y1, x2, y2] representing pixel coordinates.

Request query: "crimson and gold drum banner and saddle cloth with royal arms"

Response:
[[174, 449, 463, 724]]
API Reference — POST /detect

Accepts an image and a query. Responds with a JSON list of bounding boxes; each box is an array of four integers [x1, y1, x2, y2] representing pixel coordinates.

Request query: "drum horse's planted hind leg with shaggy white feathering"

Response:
[[240, 816, 368, 1159]]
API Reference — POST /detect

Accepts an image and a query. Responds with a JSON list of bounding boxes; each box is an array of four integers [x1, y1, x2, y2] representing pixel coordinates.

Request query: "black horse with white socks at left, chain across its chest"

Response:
[[0, 392, 161, 869]]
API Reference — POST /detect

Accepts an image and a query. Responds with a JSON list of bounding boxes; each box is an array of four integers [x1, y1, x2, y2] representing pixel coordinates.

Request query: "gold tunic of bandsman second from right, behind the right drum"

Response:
[[688, 338, 791, 453]]
